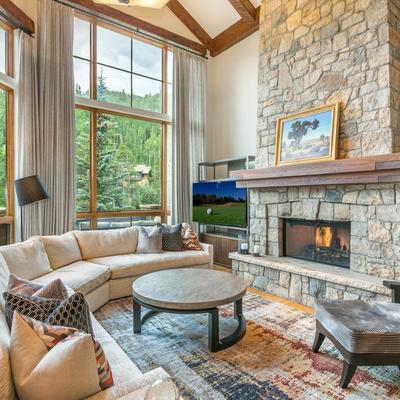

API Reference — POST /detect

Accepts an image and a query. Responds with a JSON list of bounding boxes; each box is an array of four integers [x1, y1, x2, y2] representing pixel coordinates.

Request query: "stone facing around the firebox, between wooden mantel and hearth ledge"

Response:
[[250, 184, 400, 279]]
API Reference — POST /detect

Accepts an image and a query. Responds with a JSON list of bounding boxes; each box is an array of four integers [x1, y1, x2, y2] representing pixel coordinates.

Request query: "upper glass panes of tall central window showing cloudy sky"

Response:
[[74, 18, 166, 112]]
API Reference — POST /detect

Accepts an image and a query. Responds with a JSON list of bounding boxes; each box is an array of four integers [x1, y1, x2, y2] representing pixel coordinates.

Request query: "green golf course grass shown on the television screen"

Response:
[[193, 202, 247, 226]]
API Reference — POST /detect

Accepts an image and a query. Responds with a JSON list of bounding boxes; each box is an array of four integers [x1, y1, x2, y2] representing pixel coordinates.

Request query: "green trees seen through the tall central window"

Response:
[[76, 78, 162, 212]]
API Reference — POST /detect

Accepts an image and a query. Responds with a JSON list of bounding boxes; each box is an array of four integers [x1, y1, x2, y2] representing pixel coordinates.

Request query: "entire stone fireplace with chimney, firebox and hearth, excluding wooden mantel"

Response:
[[228, 0, 400, 305]]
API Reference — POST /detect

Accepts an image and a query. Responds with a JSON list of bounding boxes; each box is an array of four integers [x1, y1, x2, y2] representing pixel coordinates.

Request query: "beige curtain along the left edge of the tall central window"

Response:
[[37, 0, 76, 235]]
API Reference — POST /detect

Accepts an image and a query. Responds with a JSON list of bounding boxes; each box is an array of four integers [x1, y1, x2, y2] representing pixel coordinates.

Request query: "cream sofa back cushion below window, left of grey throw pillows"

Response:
[[73, 228, 138, 260]]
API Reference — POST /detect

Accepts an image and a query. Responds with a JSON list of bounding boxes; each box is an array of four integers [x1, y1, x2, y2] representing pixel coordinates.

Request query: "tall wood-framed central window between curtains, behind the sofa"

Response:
[[74, 15, 172, 229]]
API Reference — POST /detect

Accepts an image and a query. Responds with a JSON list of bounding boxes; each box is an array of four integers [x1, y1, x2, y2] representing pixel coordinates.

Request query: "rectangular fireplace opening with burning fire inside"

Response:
[[284, 219, 350, 268]]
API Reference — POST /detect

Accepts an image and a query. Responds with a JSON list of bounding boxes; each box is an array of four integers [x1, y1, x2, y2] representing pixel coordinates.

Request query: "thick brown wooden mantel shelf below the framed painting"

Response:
[[230, 153, 400, 189]]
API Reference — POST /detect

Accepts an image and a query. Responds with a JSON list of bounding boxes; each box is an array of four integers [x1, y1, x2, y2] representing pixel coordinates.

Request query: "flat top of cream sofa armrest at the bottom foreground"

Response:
[[86, 368, 169, 400]]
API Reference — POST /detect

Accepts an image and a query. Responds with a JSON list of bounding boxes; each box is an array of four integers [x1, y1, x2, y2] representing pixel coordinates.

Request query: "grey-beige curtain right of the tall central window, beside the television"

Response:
[[171, 49, 207, 223]]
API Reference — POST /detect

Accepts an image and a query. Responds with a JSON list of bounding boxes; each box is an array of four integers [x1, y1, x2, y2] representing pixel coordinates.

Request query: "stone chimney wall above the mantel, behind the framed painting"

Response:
[[257, 0, 400, 167]]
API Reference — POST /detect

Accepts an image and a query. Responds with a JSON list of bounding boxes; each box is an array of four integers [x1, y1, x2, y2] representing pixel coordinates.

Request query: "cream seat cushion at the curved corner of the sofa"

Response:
[[34, 261, 111, 294]]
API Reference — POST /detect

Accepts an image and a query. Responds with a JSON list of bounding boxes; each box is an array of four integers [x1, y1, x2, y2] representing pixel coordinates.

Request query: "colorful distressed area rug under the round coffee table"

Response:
[[96, 293, 400, 400]]
